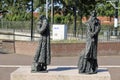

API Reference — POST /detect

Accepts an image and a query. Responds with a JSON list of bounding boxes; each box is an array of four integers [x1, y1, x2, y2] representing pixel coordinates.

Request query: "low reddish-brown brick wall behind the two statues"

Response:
[[3, 41, 120, 56]]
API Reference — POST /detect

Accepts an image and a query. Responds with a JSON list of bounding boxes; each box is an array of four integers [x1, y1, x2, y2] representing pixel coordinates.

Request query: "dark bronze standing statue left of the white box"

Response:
[[31, 15, 51, 72]]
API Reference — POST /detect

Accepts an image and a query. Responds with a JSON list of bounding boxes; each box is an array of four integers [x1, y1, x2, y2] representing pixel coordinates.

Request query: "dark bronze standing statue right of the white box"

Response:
[[78, 11, 101, 74]]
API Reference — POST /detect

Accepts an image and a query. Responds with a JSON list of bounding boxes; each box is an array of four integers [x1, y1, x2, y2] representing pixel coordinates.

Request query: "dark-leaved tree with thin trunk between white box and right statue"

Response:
[[55, 0, 102, 37]]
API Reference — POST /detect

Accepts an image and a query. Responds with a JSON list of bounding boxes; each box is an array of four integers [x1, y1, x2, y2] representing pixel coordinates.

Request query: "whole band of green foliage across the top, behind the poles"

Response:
[[0, 0, 118, 24]]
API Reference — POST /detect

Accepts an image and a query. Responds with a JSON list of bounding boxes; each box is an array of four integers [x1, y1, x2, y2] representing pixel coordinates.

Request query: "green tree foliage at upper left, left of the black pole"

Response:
[[0, 0, 31, 21]]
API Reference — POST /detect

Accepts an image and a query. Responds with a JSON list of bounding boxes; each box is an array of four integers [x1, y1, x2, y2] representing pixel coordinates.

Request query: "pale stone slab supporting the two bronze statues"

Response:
[[11, 66, 111, 80]]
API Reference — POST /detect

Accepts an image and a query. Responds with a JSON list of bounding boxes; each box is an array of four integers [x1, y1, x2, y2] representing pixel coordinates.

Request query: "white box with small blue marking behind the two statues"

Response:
[[52, 24, 67, 40]]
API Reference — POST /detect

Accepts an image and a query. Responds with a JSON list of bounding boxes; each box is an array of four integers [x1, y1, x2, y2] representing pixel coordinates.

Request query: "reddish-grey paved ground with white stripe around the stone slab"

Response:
[[0, 54, 120, 80]]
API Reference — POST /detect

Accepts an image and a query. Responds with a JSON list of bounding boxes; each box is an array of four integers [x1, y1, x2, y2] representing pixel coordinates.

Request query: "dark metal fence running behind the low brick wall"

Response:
[[0, 20, 120, 42]]
